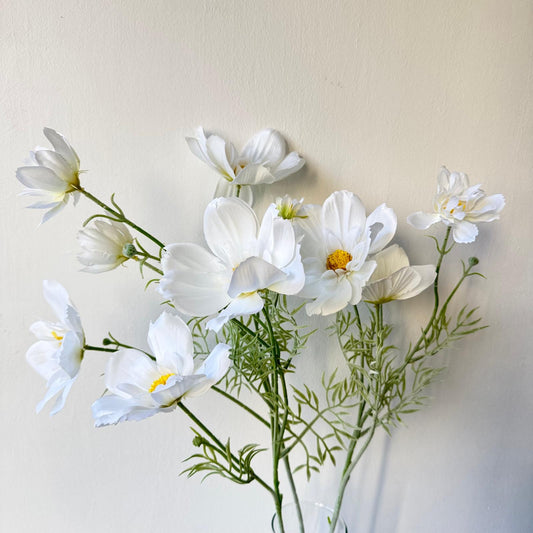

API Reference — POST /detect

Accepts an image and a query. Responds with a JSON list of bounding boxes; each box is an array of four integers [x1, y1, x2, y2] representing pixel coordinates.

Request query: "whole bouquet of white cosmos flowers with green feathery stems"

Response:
[[17, 128, 505, 533]]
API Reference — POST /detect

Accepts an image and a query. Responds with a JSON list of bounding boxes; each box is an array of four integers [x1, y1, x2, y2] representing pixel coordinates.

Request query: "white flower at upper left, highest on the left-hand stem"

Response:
[[16, 128, 80, 222]]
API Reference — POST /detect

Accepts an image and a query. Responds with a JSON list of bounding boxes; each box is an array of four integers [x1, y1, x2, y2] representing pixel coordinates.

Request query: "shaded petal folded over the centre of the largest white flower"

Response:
[[228, 257, 287, 298]]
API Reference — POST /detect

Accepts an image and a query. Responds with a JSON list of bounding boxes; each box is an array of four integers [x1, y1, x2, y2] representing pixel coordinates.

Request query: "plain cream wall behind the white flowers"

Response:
[[0, 0, 533, 533]]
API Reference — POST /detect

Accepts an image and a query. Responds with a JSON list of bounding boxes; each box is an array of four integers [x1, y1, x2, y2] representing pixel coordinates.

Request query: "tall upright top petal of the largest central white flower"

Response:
[[204, 198, 259, 268]]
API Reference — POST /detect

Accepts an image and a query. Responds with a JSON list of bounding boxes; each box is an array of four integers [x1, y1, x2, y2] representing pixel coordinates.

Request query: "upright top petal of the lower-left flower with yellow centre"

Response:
[[148, 312, 194, 376]]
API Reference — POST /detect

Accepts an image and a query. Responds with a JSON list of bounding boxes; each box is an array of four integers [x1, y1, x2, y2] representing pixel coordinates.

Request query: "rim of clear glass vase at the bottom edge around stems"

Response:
[[272, 501, 348, 533]]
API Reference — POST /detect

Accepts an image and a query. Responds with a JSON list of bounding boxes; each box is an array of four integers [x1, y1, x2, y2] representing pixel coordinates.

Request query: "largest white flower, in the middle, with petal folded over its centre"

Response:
[[159, 198, 304, 330]]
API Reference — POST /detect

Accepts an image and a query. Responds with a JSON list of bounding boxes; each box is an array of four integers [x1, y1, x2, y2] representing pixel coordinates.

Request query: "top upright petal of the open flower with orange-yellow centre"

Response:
[[322, 191, 366, 249]]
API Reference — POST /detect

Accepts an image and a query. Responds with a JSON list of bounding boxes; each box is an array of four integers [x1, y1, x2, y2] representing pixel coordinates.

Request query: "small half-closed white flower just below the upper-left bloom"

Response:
[[78, 220, 135, 273]]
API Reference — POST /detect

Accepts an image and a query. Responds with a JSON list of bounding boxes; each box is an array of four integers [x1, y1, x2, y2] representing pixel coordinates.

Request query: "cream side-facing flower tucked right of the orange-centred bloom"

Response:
[[363, 244, 436, 304]]
